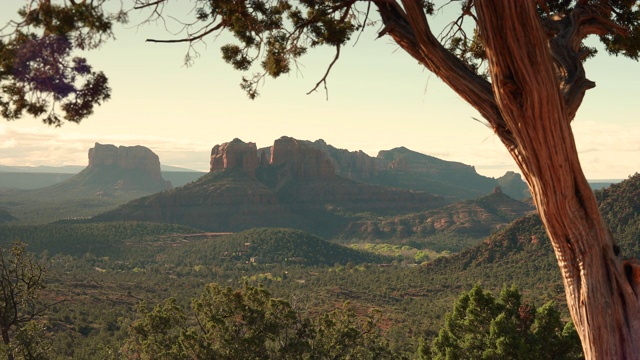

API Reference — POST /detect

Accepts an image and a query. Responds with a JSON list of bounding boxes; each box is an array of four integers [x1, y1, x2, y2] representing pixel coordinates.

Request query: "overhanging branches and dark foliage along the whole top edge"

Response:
[[0, 0, 640, 125]]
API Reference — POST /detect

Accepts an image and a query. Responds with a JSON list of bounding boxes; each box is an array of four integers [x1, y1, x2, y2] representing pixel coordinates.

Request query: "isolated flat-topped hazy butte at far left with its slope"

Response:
[[0, 143, 171, 223]]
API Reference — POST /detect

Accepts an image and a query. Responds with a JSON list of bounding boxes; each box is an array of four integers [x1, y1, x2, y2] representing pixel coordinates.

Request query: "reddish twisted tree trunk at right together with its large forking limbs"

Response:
[[375, 0, 640, 359]]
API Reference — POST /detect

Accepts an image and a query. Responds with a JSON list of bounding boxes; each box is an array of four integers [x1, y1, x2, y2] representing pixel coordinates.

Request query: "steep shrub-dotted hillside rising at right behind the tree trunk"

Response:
[[422, 174, 640, 301]]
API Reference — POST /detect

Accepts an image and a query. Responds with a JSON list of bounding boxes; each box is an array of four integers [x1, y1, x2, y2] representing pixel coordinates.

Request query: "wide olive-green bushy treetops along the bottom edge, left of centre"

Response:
[[123, 284, 398, 360]]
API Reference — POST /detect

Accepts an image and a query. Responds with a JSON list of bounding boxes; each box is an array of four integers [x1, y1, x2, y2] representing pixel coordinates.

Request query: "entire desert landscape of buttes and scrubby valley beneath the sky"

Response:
[[0, 137, 640, 359]]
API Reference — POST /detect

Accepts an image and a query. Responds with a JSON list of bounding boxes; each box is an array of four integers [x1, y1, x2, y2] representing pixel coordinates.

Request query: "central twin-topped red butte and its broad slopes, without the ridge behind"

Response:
[[93, 137, 446, 236]]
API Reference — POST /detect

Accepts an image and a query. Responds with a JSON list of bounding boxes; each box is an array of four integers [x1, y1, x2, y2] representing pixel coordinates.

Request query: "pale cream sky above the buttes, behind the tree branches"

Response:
[[0, 0, 640, 179]]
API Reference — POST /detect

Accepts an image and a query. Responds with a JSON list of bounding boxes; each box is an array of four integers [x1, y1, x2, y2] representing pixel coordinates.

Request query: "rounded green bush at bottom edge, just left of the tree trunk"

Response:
[[428, 286, 582, 360]]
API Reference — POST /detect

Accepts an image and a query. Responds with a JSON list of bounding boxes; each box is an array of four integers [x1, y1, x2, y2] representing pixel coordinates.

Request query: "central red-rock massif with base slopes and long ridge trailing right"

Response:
[[90, 136, 528, 237]]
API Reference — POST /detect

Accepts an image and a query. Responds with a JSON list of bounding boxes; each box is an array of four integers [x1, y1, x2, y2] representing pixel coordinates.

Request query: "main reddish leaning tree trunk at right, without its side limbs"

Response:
[[475, 0, 640, 359]]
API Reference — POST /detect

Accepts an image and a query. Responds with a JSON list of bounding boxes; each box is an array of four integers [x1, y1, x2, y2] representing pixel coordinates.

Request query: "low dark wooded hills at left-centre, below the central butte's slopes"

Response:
[[0, 222, 393, 268]]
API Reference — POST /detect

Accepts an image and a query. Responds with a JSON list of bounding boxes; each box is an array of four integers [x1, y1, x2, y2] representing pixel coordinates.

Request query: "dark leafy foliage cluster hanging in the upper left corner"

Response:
[[0, 0, 126, 126]]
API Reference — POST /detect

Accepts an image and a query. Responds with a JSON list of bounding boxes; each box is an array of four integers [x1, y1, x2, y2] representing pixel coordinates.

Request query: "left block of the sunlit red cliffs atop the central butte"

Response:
[[209, 138, 258, 177]]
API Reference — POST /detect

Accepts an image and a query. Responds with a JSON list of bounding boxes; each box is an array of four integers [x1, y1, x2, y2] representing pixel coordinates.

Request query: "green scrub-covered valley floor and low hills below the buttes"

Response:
[[0, 172, 640, 359]]
